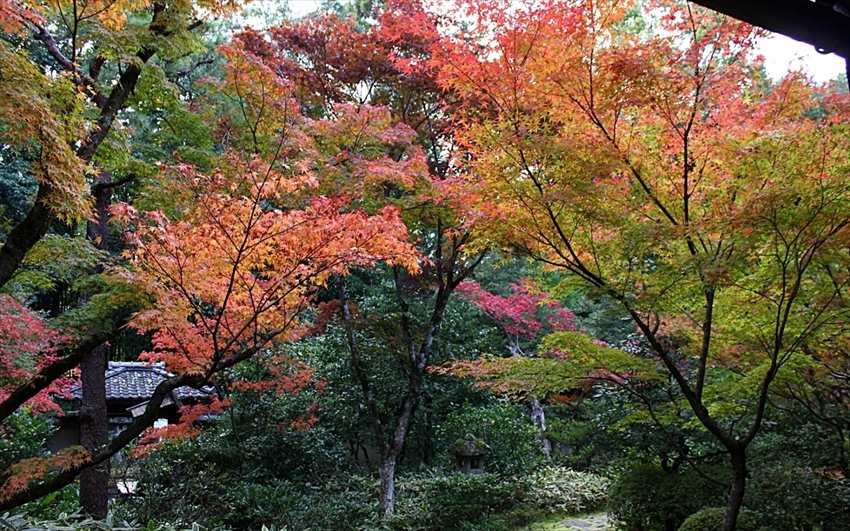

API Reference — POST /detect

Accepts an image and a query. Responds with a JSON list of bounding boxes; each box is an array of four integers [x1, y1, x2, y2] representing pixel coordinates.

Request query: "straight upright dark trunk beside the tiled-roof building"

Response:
[[80, 173, 112, 519]]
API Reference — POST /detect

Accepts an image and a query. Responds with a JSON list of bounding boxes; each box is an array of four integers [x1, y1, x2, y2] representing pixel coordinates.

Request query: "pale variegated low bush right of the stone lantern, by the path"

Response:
[[525, 466, 611, 513]]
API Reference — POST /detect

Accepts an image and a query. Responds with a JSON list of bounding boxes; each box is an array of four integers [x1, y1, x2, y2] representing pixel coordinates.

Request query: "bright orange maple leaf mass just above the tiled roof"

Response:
[[113, 153, 418, 376]]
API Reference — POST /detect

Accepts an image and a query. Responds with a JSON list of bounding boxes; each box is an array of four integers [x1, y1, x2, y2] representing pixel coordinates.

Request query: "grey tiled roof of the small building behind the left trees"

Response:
[[71, 361, 215, 402]]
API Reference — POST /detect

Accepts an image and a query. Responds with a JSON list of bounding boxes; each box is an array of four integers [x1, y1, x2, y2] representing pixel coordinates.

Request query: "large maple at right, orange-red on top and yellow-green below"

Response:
[[424, 1, 850, 531]]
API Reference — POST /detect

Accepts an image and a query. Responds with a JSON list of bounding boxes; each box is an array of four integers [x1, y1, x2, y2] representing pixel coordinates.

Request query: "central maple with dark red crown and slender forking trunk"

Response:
[[229, 2, 484, 514]]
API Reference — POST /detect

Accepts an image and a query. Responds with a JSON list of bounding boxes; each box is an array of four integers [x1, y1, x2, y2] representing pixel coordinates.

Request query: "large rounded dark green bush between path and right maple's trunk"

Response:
[[608, 466, 725, 531]]
